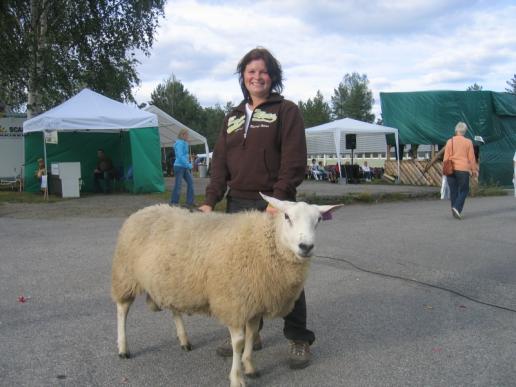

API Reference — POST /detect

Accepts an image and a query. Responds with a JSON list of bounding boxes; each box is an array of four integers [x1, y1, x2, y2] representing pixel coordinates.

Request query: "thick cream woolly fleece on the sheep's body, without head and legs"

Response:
[[112, 205, 309, 326]]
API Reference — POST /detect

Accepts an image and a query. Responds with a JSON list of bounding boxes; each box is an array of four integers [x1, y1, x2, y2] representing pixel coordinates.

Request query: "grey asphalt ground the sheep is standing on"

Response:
[[0, 197, 516, 386]]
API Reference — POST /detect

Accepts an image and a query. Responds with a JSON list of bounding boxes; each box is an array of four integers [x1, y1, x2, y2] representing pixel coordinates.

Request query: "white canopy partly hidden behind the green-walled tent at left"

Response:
[[143, 105, 210, 166]]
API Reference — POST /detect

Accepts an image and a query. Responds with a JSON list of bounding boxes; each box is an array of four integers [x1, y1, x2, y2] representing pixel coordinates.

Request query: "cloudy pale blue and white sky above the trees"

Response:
[[133, 0, 516, 116]]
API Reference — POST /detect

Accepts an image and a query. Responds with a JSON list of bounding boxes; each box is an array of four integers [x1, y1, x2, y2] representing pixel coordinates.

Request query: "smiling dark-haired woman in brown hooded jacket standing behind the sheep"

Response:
[[199, 48, 315, 368]]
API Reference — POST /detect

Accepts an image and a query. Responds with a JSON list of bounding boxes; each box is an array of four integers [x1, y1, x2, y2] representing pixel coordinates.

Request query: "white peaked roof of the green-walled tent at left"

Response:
[[23, 89, 158, 133]]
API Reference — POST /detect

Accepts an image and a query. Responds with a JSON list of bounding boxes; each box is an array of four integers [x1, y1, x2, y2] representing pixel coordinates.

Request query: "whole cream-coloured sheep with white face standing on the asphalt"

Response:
[[111, 195, 340, 387]]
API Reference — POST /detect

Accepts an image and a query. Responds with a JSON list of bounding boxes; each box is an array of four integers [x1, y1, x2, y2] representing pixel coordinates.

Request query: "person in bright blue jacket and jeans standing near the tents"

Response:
[[170, 129, 194, 207]]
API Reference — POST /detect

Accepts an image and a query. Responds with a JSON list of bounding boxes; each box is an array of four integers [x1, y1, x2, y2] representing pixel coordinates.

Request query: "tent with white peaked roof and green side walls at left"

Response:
[[23, 89, 165, 193]]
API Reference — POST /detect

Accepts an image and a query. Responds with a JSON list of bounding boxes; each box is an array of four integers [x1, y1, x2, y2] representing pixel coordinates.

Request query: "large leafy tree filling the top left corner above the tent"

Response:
[[0, 0, 166, 116]]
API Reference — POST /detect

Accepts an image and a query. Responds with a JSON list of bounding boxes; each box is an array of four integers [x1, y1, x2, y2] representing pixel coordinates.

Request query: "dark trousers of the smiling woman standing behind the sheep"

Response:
[[226, 197, 315, 345]]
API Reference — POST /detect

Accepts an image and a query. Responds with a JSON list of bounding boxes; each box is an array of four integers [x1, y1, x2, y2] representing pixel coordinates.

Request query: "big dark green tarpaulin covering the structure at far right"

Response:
[[380, 91, 516, 186]]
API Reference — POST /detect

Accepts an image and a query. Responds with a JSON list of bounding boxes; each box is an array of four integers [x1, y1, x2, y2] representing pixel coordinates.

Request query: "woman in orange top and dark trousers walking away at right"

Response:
[[444, 122, 478, 219]]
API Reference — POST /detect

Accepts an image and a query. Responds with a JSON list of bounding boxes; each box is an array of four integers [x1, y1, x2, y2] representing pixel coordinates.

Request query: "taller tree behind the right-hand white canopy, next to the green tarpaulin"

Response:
[[331, 73, 374, 122]]
